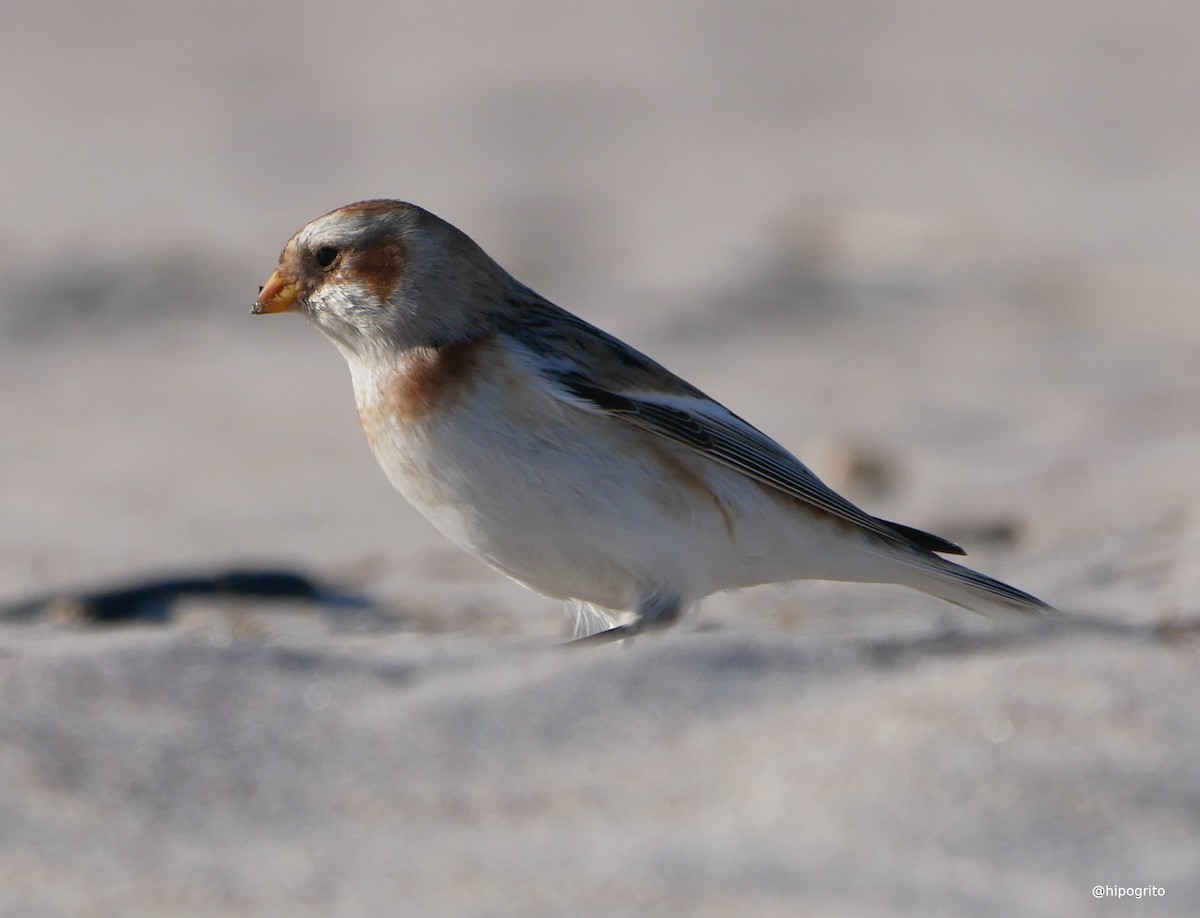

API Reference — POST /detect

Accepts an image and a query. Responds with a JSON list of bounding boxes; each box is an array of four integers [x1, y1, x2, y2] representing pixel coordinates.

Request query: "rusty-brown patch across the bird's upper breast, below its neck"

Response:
[[359, 338, 490, 445]]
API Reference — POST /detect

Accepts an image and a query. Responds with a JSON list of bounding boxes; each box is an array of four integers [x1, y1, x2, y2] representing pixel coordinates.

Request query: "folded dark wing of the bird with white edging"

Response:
[[503, 294, 965, 554]]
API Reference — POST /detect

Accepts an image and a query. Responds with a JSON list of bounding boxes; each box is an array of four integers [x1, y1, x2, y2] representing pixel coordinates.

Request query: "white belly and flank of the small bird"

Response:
[[354, 350, 873, 610]]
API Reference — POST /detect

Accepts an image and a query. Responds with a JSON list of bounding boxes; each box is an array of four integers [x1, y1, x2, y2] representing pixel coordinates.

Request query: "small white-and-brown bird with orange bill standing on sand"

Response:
[[251, 199, 1055, 641]]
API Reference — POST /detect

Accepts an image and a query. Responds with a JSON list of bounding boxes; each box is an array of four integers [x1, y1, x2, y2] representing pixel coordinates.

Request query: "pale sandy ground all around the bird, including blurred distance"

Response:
[[0, 0, 1200, 916]]
